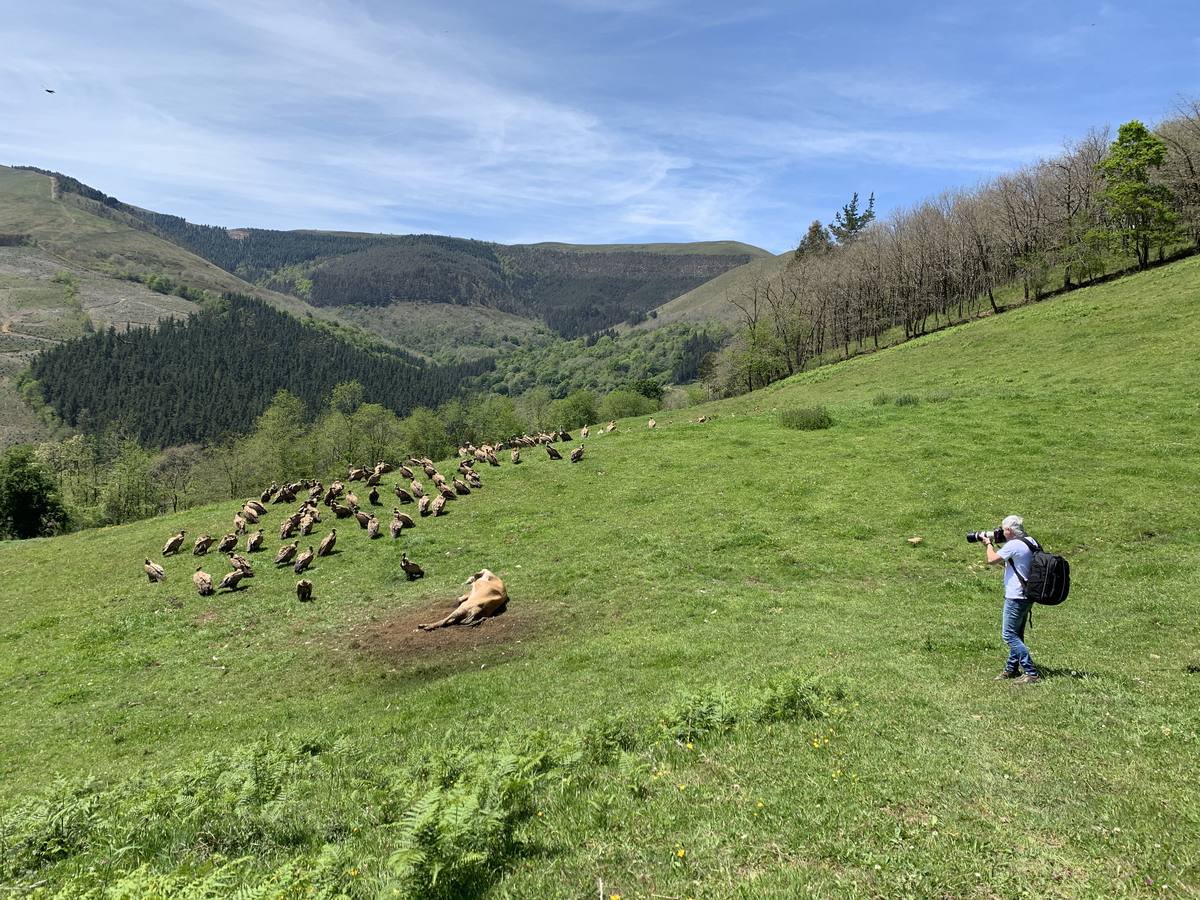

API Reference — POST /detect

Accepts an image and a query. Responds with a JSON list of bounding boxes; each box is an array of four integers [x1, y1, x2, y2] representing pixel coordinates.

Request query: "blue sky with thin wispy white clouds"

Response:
[[0, 0, 1200, 252]]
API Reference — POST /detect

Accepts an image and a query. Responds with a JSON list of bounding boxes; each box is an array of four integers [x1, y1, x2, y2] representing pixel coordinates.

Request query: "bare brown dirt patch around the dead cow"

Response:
[[349, 599, 538, 665]]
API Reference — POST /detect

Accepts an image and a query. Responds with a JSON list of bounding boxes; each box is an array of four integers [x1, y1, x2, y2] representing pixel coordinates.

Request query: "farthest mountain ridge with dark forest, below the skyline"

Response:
[[11, 173, 766, 337]]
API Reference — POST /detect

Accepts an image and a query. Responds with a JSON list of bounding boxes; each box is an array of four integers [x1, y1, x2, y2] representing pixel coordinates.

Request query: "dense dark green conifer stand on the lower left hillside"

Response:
[[31, 294, 490, 446]]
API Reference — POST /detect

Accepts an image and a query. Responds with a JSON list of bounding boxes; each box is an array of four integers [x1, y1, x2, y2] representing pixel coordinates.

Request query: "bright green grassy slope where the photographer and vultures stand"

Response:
[[0, 259, 1200, 898]]
